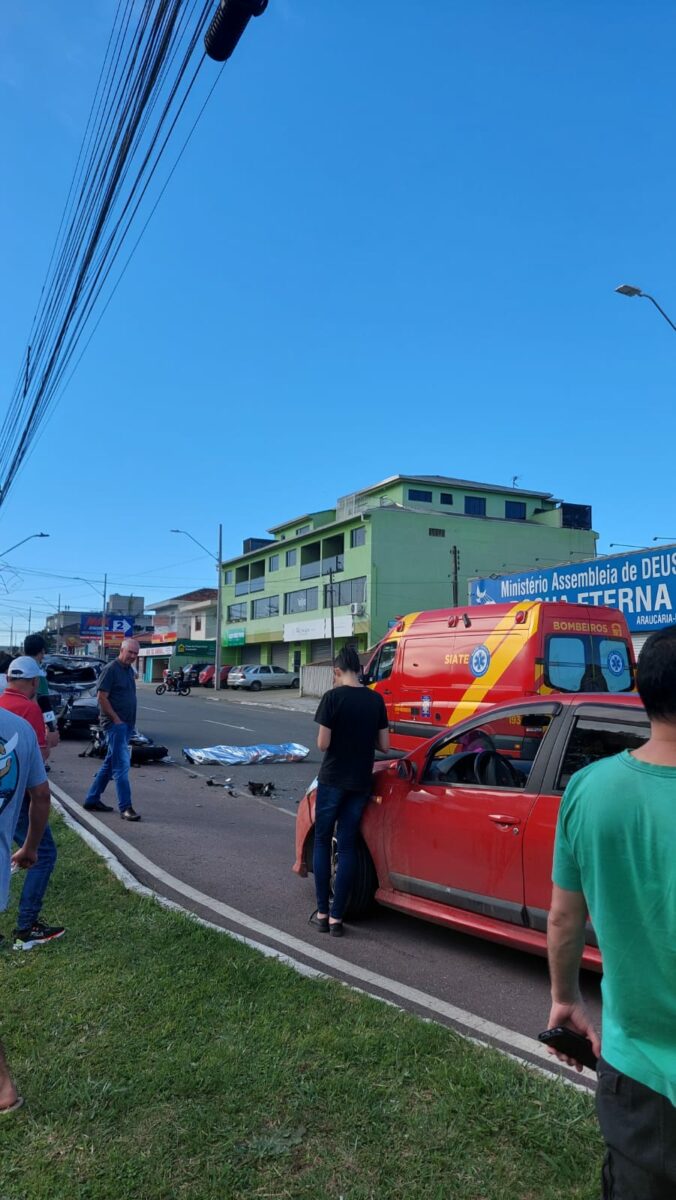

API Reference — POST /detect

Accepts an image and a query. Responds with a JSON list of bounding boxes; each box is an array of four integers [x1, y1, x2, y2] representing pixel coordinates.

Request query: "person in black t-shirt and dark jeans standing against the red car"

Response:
[[311, 646, 389, 937]]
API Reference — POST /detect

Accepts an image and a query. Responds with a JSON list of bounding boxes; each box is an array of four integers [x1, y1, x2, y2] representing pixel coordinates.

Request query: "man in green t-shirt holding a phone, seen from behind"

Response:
[[548, 625, 676, 1200]]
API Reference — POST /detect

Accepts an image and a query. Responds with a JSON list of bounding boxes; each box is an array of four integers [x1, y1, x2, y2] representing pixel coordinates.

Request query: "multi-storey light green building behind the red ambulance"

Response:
[[222, 475, 597, 671]]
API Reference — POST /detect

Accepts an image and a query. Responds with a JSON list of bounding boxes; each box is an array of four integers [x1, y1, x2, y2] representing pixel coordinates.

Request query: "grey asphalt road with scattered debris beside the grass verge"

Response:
[[50, 688, 600, 1089]]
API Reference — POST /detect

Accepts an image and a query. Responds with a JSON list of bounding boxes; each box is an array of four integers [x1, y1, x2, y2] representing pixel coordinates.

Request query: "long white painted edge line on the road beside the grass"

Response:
[[50, 782, 593, 1092]]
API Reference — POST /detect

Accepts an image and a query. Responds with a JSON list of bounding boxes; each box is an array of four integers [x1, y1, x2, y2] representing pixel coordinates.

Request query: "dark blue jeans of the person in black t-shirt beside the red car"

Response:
[[312, 784, 369, 920]]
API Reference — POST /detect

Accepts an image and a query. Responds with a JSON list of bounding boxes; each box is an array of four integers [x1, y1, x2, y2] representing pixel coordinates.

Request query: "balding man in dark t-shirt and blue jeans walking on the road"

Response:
[[84, 637, 140, 821]]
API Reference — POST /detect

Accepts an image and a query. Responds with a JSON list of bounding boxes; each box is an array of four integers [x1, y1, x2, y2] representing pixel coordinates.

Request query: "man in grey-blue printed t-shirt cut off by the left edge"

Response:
[[0, 709, 49, 1117]]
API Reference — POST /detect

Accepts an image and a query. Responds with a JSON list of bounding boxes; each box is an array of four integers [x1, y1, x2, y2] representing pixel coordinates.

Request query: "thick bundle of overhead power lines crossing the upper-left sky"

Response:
[[0, 0, 230, 504]]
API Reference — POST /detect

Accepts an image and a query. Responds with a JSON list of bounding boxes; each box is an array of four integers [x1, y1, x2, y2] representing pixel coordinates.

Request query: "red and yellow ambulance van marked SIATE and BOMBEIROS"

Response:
[[364, 600, 635, 750]]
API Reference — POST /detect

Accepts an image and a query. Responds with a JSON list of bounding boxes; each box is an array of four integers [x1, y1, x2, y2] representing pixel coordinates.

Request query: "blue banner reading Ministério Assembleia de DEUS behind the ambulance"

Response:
[[469, 545, 676, 634]]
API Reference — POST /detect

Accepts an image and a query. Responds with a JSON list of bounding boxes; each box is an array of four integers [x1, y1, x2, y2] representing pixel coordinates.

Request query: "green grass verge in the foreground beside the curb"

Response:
[[0, 820, 600, 1200]]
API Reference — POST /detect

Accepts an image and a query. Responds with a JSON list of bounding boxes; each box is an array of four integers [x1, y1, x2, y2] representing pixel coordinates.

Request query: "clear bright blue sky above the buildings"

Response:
[[0, 0, 676, 641]]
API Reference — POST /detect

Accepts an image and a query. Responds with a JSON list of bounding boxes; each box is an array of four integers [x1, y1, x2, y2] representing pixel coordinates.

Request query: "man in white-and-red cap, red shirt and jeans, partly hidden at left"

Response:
[[0, 655, 65, 950]]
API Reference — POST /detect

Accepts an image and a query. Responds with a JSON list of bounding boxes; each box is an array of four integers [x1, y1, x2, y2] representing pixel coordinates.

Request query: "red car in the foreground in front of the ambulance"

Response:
[[293, 694, 650, 970]]
